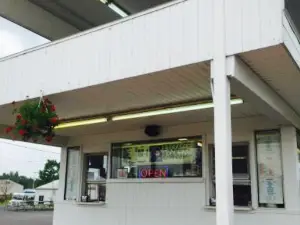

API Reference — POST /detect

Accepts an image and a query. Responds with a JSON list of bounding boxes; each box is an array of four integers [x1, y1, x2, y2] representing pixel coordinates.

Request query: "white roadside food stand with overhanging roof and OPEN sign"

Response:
[[0, 0, 300, 225]]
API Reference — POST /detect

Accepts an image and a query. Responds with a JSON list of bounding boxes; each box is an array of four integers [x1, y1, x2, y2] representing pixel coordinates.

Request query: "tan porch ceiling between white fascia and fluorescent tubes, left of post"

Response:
[[46, 60, 211, 118]]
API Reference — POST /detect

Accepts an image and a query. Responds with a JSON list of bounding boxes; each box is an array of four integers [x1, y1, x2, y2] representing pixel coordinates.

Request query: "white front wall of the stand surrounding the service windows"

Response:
[[54, 117, 300, 225]]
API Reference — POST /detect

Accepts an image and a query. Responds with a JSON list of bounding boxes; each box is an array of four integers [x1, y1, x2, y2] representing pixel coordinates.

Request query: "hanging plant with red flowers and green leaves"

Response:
[[6, 97, 59, 142]]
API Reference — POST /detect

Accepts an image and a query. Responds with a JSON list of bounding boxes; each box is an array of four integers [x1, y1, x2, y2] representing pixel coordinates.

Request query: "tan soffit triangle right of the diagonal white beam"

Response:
[[241, 45, 300, 114]]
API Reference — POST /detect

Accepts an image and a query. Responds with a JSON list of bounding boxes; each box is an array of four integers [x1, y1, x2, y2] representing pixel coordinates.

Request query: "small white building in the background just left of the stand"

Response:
[[35, 180, 59, 203]]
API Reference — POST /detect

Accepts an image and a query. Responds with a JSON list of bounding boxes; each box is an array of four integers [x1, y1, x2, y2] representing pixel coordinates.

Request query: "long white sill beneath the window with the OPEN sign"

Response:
[[106, 177, 204, 184]]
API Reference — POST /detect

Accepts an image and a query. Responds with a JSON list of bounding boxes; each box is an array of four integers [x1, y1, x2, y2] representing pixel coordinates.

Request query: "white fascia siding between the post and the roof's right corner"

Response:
[[225, 0, 284, 55]]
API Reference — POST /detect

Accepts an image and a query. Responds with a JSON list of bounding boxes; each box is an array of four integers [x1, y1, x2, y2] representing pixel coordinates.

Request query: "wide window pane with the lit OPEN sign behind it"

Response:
[[111, 138, 202, 179]]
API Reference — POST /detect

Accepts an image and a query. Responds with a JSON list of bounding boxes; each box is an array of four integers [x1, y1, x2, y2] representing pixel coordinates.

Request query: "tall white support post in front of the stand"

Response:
[[211, 0, 233, 225]]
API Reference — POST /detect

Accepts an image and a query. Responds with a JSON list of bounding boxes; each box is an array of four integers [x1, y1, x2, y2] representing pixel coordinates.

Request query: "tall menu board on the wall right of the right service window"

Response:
[[256, 131, 284, 204]]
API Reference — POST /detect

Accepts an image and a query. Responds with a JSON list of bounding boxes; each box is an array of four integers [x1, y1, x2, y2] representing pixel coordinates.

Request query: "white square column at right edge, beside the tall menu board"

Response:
[[281, 126, 300, 211]]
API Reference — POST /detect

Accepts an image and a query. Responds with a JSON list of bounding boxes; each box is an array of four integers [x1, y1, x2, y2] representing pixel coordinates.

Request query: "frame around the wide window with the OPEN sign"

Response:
[[107, 135, 206, 179]]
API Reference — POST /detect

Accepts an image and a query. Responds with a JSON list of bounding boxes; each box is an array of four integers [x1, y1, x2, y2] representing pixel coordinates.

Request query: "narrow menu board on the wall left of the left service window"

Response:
[[65, 148, 80, 200]]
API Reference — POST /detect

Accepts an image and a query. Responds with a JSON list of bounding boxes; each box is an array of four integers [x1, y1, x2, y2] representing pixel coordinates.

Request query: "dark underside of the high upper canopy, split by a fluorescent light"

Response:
[[29, 0, 172, 31]]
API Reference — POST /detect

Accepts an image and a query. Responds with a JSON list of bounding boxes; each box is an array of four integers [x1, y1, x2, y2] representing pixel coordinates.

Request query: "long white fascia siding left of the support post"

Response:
[[0, 0, 212, 105]]
